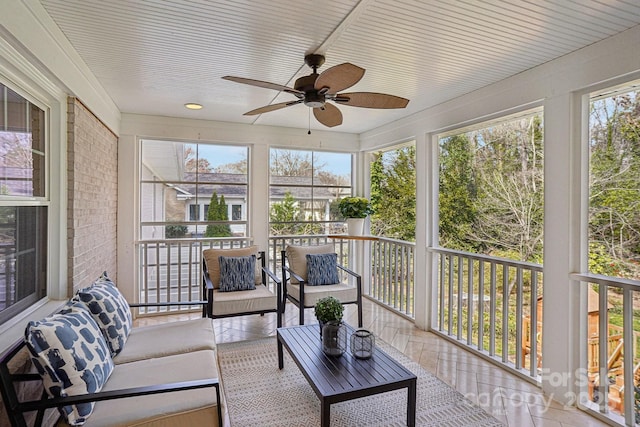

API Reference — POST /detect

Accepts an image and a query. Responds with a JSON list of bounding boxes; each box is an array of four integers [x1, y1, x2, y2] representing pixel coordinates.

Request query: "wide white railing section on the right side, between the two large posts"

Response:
[[429, 248, 542, 380]]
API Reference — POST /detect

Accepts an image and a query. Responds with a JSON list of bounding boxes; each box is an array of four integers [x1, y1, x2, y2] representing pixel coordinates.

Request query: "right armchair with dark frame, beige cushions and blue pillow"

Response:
[[282, 244, 362, 328]]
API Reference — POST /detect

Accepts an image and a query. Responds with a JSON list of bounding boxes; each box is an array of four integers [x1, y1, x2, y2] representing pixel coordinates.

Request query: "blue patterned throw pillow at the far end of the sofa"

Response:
[[74, 272, 133, 356]]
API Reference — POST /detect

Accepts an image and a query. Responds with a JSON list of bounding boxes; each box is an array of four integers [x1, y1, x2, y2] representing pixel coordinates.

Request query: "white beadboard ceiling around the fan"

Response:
[[40, 0, 640, 133]]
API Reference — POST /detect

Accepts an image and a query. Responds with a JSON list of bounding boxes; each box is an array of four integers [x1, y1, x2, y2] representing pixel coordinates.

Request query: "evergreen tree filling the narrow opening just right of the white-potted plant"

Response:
[[371, 146, 416, 241]]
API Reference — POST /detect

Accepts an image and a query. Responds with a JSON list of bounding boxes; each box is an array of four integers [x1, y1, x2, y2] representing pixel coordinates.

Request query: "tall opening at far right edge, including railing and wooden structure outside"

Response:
[[583, 82, 640, 425]]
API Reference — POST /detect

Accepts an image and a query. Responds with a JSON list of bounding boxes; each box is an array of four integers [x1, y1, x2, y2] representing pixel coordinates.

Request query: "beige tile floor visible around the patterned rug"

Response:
[[135, 300, 607, 427]]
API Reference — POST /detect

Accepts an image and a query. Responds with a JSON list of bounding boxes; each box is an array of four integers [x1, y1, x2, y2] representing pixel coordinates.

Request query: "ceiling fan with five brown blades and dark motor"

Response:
[[222, 54, 409, 127]]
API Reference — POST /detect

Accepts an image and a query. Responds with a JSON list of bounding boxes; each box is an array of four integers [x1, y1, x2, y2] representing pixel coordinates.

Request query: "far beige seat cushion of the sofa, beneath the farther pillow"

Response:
[[113, 318, 216, 365]]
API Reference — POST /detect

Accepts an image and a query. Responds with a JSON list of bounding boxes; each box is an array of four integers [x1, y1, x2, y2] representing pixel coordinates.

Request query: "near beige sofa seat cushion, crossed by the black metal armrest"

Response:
[[74, 350, 226, 427]]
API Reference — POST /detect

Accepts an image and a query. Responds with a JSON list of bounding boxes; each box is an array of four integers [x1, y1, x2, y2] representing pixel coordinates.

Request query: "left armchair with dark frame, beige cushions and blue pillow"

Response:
[[202, 246, 282, 327]]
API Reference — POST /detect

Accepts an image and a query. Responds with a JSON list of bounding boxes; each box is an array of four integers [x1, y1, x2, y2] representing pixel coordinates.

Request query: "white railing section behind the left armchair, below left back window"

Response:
[[137, 237, 251, 315]]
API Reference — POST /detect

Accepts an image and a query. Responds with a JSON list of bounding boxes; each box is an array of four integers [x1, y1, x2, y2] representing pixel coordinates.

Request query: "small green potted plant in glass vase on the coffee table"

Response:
[[314, 296, 347, 356]]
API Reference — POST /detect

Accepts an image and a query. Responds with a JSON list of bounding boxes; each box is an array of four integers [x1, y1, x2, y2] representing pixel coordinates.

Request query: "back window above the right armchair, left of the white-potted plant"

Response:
[[269, 149, 352, 236]]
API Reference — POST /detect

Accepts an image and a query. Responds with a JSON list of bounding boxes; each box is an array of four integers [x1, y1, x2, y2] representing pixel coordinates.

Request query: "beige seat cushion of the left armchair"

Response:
[[211, 285, 278, 316]]
